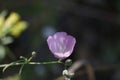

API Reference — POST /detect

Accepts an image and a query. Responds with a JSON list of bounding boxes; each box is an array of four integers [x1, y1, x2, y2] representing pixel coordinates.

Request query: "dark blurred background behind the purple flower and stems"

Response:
[[0, 0, 120, 80]]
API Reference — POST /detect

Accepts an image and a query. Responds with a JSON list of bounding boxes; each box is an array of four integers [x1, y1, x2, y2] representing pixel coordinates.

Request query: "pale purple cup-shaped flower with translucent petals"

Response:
[[47, 32, 76, 59]]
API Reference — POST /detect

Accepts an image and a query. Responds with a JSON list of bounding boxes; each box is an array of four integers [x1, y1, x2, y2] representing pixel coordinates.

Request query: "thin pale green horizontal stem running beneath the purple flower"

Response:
[[0, 61, 63, 68]]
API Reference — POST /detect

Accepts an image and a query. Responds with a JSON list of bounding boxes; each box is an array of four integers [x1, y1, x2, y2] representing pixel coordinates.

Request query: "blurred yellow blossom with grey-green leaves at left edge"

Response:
[[0, 11, 28, 60]]
